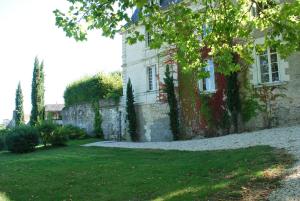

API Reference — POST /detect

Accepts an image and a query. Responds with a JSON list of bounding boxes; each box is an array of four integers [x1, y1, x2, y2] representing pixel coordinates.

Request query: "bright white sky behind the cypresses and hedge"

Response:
[[0, 0, 122, 123]]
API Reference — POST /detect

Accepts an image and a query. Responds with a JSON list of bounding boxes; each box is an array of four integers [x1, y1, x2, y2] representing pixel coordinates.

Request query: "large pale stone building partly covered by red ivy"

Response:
[[121, 0, 300, 141]]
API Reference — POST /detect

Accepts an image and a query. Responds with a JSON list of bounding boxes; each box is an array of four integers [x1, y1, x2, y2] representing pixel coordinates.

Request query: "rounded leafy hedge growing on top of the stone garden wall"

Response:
[[64, 72, 122, 107]]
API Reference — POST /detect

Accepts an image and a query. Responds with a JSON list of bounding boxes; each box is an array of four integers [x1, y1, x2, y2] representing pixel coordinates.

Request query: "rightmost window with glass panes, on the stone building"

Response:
[[258, 48, 279, 83]]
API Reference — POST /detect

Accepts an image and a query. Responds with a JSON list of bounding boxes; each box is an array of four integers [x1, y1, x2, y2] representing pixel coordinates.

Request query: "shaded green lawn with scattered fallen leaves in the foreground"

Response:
[[0, 141, 293, 201]]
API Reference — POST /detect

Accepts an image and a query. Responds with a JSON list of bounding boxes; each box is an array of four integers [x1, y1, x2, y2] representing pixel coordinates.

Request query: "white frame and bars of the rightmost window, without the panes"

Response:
[[256, 47, 282, 84]]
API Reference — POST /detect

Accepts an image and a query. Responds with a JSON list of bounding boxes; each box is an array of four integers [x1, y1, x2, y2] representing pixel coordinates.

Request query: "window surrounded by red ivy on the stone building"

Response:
[[198, 59, 216, 93]]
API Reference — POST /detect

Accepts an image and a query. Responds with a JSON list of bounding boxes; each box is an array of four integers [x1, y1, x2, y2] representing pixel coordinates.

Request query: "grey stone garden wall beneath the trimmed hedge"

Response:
[[62, 100, 122, 140]]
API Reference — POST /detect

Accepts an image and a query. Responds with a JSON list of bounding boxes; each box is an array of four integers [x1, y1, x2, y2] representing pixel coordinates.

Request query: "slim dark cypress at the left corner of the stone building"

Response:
[[126, 79, 139, 142]]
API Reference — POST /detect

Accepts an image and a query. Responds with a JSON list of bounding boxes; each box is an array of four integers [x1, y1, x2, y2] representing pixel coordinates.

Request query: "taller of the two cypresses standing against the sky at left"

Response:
[[30, 57, 45, 126]]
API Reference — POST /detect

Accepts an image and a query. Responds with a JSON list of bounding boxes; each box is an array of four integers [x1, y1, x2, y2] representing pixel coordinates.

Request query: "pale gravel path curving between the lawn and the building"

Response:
[[85, 126, 300, 201]]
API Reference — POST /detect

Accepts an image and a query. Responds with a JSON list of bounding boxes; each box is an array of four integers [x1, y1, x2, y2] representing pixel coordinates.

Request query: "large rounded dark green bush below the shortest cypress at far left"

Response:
[[6, 126, 39, 153]]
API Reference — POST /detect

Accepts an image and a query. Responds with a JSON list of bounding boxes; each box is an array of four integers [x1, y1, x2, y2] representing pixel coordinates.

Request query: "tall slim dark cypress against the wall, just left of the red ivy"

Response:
[[164, 65, 180, 140]]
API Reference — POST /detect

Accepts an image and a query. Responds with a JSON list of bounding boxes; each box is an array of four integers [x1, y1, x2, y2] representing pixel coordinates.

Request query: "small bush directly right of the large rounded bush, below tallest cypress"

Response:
[[37, 121, 58, 146]]
